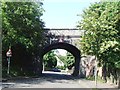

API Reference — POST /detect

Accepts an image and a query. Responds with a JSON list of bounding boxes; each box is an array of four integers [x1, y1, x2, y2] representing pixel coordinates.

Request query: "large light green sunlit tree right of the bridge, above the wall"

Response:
[[79, 2, 120, 87]]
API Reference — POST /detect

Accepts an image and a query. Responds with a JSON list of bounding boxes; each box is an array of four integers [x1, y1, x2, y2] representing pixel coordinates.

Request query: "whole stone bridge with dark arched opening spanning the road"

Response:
[[40, 28, 84, 76]]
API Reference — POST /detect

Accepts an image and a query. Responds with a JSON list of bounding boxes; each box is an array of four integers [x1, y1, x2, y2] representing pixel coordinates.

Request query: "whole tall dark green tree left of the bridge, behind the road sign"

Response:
[[2, 2, 44, 76]]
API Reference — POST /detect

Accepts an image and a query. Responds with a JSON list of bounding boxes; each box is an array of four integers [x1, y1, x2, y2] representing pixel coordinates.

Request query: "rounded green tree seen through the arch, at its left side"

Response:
[[43, 51, 57, 69]]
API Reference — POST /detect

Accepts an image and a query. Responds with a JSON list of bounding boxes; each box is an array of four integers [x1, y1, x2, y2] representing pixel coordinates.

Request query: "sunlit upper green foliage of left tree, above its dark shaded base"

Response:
[[2, 2, 44, 50]]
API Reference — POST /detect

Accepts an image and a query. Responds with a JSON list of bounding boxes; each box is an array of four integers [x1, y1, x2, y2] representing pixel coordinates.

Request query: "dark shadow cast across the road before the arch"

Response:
[[3, 72, 80, 83]]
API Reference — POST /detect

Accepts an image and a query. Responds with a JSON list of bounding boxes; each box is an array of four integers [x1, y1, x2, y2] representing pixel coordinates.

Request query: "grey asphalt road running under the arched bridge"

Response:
[[2, 71, 115, 88]]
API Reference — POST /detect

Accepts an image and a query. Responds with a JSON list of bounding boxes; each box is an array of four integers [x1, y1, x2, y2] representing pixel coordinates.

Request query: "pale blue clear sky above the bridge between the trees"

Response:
[[42, 0, 99, 28]]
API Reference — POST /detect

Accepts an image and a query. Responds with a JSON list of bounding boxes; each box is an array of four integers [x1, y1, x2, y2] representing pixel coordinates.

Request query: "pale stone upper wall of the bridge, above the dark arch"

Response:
[[45, 28, 84, 48]]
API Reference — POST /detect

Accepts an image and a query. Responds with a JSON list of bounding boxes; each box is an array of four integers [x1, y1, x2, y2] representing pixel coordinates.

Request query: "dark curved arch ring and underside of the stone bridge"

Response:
[[41, 42, 81, 76]]
